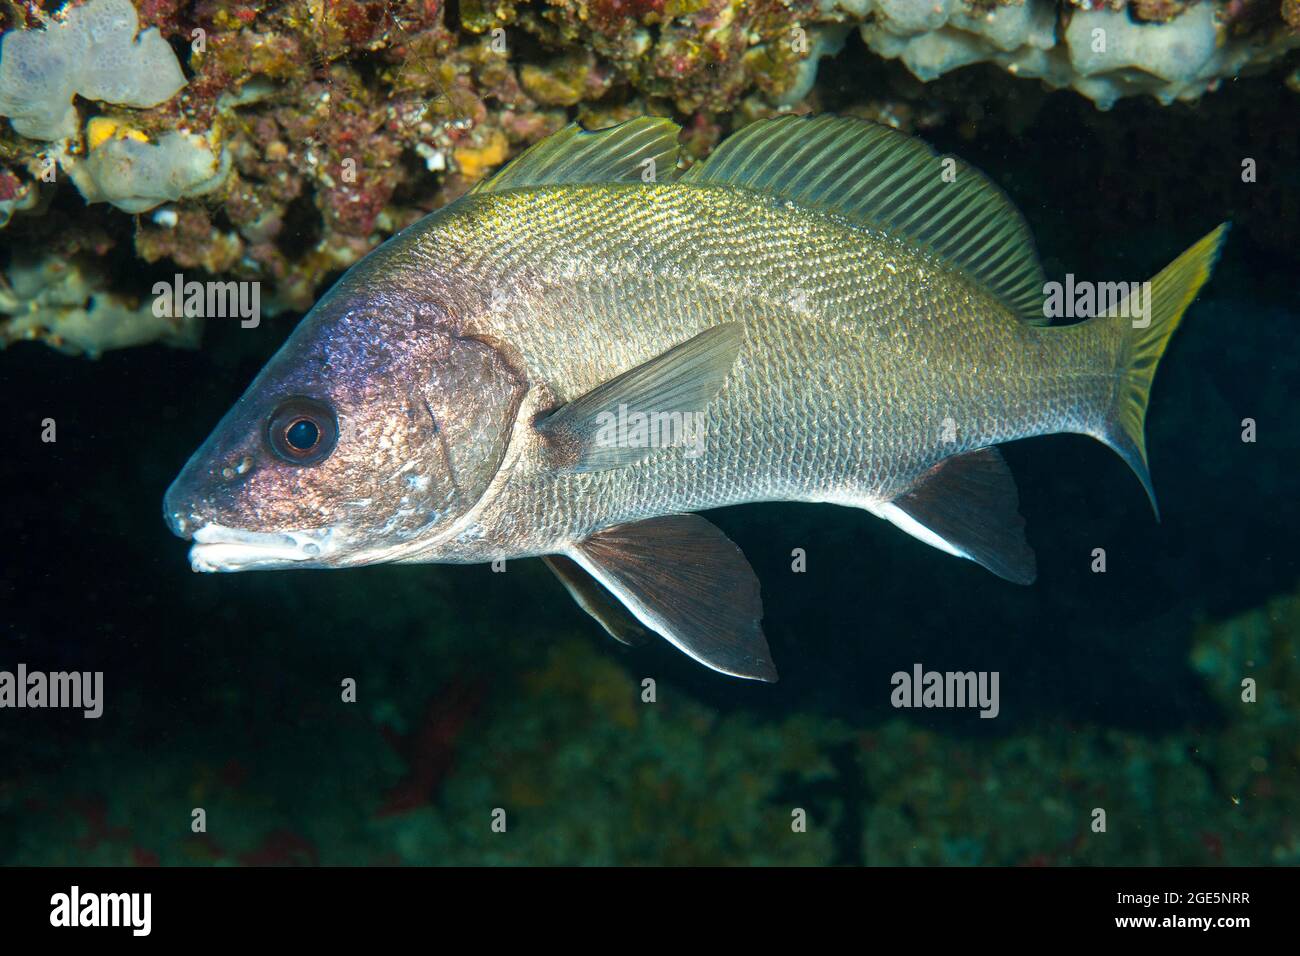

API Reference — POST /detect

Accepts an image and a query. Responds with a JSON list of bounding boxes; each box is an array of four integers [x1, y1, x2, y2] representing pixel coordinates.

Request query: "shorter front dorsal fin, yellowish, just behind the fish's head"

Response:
[[471, 116, 681, 193]]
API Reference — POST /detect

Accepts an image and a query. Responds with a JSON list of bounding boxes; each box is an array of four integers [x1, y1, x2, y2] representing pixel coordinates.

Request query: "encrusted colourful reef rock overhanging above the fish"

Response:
[[0, 0, 1300, 355]]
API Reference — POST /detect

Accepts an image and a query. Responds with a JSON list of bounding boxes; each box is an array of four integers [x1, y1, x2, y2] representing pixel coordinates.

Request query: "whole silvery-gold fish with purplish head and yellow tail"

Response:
[[164, 117, 1223, 679]]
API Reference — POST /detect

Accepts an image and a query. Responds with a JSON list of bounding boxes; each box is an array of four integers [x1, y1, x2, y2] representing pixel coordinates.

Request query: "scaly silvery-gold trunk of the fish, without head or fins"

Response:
[[392, 185, 1119, 561]]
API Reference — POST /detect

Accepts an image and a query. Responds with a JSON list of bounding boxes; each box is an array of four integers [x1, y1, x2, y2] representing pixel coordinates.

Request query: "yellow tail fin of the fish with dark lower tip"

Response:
[[1104, 222, 1229, 519]]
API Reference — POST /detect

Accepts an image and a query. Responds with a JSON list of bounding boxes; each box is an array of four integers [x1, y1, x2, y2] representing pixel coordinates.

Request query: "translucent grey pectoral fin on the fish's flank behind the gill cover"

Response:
[[537, 323, 745, 472]]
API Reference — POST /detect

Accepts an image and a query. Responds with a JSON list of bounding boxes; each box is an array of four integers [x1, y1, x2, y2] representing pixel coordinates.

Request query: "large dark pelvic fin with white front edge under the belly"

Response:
[[569, 515, 776, 682]]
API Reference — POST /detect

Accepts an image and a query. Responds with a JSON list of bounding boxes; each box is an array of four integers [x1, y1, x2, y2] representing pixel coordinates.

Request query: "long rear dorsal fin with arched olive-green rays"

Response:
[[680, 116, 1047, 324]]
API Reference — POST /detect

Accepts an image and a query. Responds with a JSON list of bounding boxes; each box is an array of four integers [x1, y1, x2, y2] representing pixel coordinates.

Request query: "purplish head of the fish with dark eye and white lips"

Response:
[[163, 280, 524, 571]]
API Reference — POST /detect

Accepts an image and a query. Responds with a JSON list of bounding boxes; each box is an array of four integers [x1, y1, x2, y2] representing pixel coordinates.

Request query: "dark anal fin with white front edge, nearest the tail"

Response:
[[880, 447, 1037, 584]]
